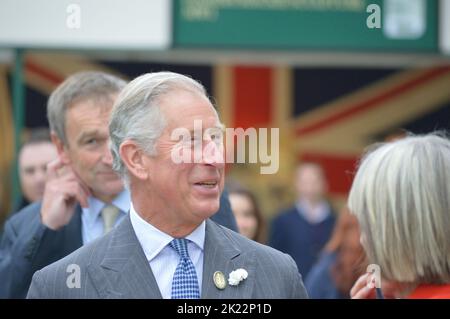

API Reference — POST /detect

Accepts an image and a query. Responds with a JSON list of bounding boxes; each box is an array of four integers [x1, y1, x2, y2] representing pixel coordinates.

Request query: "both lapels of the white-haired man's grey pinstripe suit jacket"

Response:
[[87, 216, 255, 299]]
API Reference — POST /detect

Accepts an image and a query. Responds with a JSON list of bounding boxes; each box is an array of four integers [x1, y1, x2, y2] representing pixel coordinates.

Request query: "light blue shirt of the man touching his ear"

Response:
[[81, 190, 130, 245]]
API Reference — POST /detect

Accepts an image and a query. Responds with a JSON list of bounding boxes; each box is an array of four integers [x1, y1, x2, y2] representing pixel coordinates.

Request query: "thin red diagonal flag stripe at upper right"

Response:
[[296, 67, 450, 135]]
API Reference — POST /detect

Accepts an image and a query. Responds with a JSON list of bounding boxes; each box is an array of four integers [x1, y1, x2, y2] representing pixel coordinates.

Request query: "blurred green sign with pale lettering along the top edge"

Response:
[[174, 0, 438, 52]]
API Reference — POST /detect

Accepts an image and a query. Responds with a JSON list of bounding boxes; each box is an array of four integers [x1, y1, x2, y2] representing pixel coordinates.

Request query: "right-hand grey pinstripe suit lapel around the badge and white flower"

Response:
[[202, 220, 255, 299]]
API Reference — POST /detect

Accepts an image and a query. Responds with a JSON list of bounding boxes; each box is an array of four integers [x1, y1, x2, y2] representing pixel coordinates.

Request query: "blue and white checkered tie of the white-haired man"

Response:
[[169, 238, 200, 299]]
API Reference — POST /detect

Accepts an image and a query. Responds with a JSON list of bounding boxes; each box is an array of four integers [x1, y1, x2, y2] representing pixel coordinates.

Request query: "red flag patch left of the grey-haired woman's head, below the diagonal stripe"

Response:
[[300, 153, 358, 195]]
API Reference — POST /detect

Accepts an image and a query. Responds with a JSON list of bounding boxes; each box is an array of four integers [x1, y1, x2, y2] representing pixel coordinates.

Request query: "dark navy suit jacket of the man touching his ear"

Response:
[[0, 192, 237, 298]]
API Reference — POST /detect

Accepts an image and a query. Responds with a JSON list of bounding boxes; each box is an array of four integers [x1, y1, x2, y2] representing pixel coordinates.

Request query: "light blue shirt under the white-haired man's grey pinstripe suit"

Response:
[[130, 204, 206, 299]]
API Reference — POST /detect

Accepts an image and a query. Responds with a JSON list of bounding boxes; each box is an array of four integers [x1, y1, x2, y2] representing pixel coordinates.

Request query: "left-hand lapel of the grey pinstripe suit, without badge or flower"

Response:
[[88, 216, 162, 299]]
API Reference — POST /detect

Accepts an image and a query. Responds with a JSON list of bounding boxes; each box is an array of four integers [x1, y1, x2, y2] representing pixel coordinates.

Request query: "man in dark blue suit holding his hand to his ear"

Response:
[[0, 72, 129, 298]]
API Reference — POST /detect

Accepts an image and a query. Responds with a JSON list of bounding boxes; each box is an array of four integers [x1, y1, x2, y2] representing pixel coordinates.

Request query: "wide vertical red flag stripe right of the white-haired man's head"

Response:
[[233, 66, 272, 129]]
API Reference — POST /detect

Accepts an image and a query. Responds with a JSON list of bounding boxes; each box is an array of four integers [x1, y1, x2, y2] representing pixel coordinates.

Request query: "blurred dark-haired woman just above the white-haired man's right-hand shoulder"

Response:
[[228, 183, 265, 244]]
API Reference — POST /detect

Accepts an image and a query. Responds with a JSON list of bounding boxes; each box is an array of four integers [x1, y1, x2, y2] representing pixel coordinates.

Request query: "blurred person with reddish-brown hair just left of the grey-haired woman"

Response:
[[305, 208, 367, 299]]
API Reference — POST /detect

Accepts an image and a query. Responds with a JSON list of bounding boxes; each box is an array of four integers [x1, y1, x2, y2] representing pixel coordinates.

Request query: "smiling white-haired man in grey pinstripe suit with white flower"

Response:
[[28, 72, 307, 299]]
